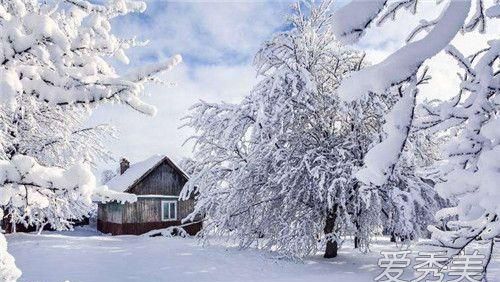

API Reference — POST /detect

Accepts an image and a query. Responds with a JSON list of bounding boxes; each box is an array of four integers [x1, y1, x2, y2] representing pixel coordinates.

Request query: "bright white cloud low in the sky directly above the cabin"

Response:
[[90, 65, 255, 165]]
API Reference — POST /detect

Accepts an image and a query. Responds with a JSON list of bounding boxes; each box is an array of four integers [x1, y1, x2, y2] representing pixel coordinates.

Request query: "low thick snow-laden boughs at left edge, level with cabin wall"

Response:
[[0, 155, 95, 229]]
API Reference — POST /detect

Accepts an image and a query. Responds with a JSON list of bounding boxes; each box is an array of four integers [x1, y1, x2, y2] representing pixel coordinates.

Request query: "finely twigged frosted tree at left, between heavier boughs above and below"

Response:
[[0, 93, 115, 167]]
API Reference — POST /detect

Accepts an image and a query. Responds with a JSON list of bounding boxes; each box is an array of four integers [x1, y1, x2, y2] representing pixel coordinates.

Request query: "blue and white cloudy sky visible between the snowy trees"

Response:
[[90, 0, 500, 174]]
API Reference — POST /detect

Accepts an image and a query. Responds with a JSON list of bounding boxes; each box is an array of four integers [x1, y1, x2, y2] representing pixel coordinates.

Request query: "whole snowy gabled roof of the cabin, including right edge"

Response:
[[106, 155, 188, 192]]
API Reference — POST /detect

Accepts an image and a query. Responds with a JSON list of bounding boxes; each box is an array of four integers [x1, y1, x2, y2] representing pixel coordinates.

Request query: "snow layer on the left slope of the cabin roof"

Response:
[[106, 155, 166, 192]]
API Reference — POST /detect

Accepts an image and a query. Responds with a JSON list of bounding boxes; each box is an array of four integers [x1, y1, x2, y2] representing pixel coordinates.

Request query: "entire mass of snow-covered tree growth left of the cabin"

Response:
[[0, 0, 181, 280]]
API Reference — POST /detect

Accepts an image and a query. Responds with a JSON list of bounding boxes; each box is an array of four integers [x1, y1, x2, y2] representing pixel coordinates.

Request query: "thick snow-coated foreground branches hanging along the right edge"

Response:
[[334, 0, 500, 276]]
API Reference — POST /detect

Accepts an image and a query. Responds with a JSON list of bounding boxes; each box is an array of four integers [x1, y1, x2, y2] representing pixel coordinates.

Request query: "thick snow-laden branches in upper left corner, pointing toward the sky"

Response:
[[0, 0, 181, 115]]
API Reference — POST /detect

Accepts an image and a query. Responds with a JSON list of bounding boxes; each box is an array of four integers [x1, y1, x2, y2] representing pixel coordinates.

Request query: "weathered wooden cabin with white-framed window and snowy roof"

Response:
[[97, 156, 201, 235]]
